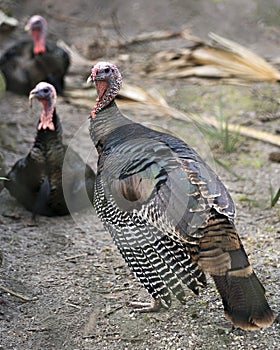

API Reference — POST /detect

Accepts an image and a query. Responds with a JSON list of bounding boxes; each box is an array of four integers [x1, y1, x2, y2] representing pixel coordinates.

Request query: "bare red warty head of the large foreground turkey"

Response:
[[88, 62, 122, 118]]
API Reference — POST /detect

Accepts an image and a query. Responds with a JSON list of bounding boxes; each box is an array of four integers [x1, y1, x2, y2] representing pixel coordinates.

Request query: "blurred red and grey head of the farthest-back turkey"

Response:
[[25, 15, 48, 54]]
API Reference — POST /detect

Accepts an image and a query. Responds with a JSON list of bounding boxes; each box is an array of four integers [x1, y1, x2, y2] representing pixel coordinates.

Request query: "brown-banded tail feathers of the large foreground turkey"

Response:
[[194, 214, 274, 329]]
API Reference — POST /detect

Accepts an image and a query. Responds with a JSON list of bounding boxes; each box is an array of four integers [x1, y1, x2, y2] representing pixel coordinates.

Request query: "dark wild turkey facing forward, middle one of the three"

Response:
[[5, 82, 95, 216]]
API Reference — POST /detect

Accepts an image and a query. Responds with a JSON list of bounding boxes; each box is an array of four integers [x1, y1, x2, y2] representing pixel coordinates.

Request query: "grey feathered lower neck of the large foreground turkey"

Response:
[[89, 101, 134, 148]]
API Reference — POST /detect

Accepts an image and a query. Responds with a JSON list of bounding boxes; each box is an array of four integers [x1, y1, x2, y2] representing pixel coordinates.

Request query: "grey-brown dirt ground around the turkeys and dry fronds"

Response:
[[0, 0, 280, 350]]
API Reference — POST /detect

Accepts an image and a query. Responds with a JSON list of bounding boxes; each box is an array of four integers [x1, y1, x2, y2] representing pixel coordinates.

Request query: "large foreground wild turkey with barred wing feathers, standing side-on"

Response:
[[88, 62, 274, 329]]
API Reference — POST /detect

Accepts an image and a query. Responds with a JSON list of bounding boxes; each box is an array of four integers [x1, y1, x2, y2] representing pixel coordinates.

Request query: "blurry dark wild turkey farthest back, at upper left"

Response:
[[0, 15, 70, 95]]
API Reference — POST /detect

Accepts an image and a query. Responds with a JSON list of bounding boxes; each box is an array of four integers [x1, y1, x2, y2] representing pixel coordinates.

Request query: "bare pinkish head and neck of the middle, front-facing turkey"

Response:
[[29, 82, 57, 130]]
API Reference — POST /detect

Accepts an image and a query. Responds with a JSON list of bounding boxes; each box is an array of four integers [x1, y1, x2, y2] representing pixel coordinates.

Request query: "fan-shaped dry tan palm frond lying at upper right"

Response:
[[146, 33, 280, 81]]
